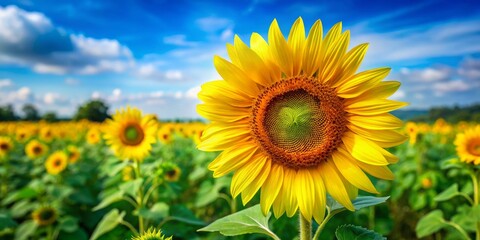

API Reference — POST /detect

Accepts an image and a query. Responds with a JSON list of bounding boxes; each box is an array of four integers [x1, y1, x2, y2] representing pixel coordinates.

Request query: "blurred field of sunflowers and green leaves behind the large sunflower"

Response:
[[0, 113, 480, 240]]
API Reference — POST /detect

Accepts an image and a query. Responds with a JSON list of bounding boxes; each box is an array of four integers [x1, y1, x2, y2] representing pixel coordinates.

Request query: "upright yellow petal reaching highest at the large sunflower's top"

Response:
[[288, 17, 305, 76]]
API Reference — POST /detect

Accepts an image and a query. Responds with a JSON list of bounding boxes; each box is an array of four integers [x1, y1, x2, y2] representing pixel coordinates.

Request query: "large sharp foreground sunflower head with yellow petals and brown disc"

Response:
[[197, 18, 406, 222]]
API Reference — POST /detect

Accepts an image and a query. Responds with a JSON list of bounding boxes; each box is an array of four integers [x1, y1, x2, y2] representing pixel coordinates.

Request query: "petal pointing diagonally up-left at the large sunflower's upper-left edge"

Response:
[[213, 56, 259, 98]]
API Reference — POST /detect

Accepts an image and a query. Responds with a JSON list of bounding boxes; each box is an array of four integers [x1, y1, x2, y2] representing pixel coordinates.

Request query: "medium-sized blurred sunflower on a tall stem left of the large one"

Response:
[[104, 107, 157, 161]]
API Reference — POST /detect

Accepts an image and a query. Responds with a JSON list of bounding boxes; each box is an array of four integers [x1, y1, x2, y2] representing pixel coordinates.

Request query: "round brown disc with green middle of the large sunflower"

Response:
[[251, 76, 347, 169]]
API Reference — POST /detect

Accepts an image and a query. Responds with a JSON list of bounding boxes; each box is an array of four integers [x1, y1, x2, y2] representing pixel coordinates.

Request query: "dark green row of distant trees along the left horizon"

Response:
[[0, 100, 110, 122]]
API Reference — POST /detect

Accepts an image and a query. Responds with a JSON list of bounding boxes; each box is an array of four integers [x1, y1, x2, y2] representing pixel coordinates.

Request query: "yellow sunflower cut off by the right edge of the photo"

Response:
[[454, 125, 480, 165]]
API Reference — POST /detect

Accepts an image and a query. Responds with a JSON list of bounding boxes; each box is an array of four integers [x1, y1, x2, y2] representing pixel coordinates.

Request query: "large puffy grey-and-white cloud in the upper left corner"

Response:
[[0, 6, 134, 75]]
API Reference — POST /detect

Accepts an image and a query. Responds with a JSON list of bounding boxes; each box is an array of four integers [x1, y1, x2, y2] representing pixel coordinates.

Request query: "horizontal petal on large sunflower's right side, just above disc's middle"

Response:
[[345, 99, 408, 116]]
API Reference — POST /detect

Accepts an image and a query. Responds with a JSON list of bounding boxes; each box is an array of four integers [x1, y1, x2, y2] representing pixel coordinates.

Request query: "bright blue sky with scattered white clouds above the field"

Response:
[[0, 0, 480, 119]]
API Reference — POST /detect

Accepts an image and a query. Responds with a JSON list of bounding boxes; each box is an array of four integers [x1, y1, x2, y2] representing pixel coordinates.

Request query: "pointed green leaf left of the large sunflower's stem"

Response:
[[198, 204, 278, 239]]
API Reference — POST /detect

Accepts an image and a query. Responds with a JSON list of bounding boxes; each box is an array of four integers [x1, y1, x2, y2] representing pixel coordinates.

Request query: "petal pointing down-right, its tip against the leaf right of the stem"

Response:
[[319, 160, 355, 211]]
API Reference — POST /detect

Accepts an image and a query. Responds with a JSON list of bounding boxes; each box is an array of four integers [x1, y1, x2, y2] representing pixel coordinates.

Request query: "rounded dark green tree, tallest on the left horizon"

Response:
[[73, 99, 110, 122]]
